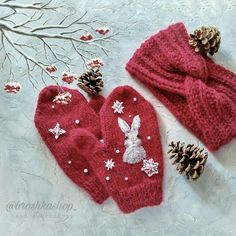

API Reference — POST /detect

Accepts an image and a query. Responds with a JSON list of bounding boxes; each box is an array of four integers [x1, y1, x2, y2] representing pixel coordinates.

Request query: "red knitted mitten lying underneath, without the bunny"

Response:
[[34, 86, 108, 203]]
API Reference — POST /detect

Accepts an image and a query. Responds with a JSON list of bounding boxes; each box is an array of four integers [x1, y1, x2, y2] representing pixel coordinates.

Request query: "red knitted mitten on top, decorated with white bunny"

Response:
[[71, 86, 163, 213]]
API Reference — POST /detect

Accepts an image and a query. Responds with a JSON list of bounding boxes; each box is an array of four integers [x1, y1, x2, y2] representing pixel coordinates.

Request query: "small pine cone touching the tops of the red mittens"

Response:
[[77, 69, 103, 95]]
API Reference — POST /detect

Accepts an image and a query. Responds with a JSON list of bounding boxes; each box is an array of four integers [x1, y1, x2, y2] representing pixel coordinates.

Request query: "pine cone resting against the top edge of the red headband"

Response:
[[189, 26, 221, 55]]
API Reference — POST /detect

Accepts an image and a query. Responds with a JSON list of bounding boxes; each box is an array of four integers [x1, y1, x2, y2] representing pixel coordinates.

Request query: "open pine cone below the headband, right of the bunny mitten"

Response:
[[168, 141, 208, 180]]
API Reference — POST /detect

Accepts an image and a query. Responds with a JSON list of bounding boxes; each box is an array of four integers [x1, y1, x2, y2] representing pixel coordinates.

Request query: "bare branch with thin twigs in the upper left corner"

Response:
[[0, 0, 117, 91]]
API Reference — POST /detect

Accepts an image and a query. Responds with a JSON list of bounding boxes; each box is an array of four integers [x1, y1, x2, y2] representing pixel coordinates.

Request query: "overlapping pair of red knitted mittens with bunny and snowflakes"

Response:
[[35, 86, 163, 213]]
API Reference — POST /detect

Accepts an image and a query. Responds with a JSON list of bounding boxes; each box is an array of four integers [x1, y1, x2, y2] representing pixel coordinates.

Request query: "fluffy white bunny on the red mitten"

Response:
[[118, 115, 146, 164]]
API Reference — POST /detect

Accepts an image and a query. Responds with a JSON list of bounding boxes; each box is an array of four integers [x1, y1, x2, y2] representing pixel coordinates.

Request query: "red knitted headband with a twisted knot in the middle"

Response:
[[126, 23, 236, 151]]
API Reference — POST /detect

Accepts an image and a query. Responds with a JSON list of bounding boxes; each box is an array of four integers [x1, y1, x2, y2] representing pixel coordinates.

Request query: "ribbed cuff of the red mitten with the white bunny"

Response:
[[112, 181, 162, 213]]
